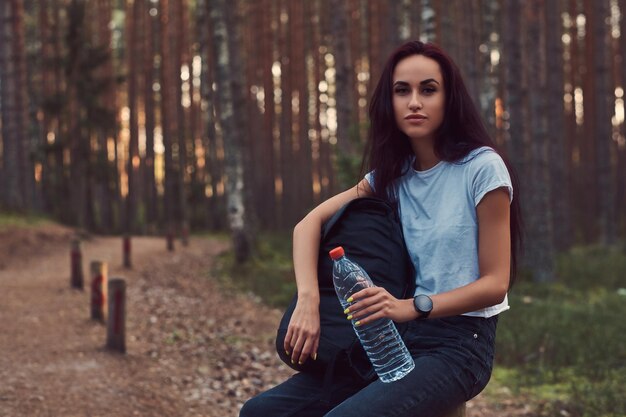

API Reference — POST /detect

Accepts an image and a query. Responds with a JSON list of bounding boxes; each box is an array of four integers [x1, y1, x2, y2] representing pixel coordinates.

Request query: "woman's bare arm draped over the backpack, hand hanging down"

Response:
[[284, 180, 372, 363]]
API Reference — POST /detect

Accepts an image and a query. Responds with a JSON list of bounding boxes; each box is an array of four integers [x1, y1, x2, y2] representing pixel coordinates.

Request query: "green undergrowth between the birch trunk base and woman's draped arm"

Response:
[[212, 234, 296, 307]]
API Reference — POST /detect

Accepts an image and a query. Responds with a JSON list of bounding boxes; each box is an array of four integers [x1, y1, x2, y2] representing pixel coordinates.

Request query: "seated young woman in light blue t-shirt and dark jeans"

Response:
[[240, 41, 520, 417]]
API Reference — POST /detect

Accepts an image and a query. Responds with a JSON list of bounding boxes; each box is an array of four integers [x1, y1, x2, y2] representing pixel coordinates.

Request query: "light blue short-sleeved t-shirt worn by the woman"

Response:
[[365, 147, 513, 317]]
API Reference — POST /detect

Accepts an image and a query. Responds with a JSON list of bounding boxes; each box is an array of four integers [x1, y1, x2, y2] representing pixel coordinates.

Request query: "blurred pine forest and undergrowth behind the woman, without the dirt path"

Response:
[[0, 0, 626, 416]]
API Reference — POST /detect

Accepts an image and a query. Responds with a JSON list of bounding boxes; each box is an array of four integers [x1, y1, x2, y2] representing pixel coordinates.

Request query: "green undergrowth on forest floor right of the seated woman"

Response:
[[496, 247, 626, 417]]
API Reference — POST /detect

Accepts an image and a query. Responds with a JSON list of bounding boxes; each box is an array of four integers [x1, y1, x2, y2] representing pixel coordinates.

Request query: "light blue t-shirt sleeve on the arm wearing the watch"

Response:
[[471, 151, 513, 206]]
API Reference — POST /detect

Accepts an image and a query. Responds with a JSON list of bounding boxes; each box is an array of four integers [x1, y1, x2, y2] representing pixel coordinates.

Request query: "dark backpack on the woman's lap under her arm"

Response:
[[276, 197, 414, 382]]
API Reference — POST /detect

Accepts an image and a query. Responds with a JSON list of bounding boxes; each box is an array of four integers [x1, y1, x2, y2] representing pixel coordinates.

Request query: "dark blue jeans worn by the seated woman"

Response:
[[239, 316, 497, 417]]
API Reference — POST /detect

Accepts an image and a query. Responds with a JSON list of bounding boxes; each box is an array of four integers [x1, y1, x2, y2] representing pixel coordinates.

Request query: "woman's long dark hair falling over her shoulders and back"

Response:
[[363, 41, 522, 285]]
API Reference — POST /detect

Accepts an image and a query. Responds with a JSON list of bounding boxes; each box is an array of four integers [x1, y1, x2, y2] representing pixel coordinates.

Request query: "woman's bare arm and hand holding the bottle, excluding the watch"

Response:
[[349, 189, 511, 324]]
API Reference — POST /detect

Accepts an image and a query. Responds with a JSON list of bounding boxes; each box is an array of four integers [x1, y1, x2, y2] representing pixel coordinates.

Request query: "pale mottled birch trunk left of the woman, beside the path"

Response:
[[208, 0, 252, 263]]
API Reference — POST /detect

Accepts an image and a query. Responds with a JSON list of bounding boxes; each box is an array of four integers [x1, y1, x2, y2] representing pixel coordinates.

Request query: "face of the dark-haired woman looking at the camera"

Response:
[[392, 55, 445, 143]]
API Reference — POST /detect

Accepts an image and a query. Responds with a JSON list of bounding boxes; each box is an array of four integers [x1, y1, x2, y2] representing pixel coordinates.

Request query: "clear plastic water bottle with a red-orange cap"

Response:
[[329, 246, 415, 382]]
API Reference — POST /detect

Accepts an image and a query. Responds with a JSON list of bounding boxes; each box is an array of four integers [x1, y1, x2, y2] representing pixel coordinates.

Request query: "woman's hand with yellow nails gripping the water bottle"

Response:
[[344, 287, 417, 326]]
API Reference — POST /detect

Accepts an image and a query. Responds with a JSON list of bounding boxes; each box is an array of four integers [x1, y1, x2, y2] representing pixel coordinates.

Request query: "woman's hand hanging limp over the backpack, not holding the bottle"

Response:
[[284, 298, 320, 365]]
